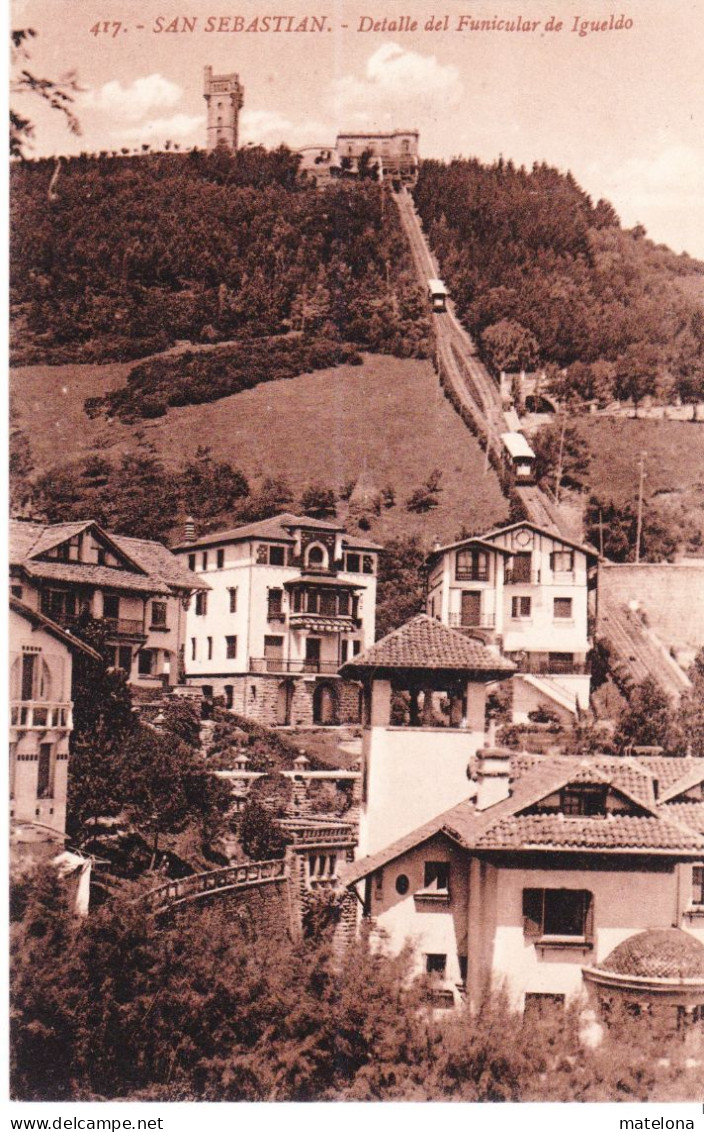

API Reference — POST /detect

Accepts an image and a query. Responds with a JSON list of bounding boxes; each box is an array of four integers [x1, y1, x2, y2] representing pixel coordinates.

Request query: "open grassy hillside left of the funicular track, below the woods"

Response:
[[11, 355, 507, 543]]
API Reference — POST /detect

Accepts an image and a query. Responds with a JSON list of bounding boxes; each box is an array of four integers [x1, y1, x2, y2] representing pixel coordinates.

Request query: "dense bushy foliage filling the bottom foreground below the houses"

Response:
[[11, 875, 702, 1101]]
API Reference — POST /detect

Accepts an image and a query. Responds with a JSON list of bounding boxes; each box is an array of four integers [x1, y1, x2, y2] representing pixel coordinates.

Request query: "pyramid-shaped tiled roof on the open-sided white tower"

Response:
[[342, 614, 516, 675]]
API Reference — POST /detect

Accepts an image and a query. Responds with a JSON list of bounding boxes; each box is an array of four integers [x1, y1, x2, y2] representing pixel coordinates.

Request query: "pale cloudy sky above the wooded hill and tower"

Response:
[[12, 0, 704, 258]]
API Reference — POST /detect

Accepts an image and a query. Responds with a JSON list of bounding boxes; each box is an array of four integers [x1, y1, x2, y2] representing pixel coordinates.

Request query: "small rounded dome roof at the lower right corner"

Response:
[[599, 927, 704, 979]]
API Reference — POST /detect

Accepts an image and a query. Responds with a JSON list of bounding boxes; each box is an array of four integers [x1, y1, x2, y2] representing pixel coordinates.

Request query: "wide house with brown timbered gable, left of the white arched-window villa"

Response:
[[10, 520, 208, 693]]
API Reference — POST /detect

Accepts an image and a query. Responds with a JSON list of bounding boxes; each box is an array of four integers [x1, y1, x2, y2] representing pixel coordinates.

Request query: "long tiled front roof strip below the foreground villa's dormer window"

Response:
[[475, 814, 704, 851]]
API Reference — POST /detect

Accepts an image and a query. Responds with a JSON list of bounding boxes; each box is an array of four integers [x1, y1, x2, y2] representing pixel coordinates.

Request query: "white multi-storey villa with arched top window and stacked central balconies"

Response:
[[174, 514, 381, 726]]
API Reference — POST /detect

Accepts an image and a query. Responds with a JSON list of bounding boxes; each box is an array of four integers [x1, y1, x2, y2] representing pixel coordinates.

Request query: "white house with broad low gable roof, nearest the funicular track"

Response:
[[427, 521, 599, 722]]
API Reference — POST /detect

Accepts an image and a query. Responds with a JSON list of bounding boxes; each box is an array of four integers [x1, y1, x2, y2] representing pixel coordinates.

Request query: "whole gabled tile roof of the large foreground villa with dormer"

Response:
[[345, 756, 704, 885]]
